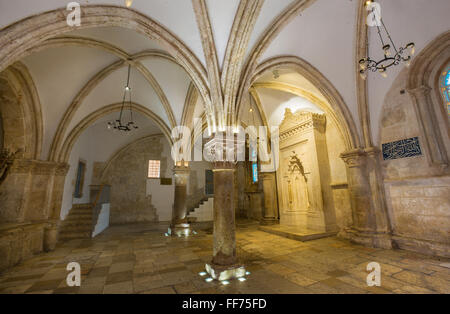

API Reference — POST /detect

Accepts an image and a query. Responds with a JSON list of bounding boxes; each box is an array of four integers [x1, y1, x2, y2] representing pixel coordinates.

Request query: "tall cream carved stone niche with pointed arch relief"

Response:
[[277, 109, 328, 231]]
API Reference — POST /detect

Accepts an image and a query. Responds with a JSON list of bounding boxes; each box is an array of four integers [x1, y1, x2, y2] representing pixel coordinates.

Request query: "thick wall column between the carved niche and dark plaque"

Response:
[[341, 149, 392, 248]]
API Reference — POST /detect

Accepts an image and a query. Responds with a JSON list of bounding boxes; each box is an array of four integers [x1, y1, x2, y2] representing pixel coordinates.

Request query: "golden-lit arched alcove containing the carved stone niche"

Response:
[[238, 57, 359, 235]]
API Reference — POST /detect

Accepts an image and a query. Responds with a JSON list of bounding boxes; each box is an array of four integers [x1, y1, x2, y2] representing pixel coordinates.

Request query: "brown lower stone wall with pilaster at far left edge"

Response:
[[0, 159, 68, 271]]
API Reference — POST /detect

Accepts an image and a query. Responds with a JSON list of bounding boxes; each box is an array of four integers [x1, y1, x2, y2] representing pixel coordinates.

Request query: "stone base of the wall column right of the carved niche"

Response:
[[339, 228, 395, 250]]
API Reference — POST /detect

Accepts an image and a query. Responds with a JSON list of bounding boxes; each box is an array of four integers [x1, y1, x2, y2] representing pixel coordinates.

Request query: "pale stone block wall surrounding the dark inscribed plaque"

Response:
[[379, 69, 450, 256]]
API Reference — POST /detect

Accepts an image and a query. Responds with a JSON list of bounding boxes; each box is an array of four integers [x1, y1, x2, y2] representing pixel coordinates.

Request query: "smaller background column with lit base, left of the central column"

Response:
[[170, 162, 191, 236]]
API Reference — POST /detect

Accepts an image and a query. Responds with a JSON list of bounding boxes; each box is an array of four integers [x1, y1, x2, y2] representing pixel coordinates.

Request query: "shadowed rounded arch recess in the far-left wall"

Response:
[[0, 63, 43, 159]]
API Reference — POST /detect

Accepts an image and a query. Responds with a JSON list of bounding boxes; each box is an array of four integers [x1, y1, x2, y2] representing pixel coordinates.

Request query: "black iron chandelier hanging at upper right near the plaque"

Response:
[[359, 0, 415, 79]]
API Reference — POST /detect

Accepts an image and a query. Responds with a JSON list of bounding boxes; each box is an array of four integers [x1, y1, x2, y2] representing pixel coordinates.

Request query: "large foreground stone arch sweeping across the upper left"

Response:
[[0, 5, 214, 129]]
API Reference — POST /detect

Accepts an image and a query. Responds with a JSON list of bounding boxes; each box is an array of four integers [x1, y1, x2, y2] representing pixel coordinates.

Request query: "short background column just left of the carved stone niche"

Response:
[[259, 172, 279, 225]]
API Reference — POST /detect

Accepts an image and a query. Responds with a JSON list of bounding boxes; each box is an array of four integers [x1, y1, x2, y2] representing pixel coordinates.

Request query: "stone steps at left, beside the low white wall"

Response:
[[59, 204, 94, 241]]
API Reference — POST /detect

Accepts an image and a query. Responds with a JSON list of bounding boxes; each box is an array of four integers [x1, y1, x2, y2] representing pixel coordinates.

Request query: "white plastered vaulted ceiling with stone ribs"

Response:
[[0, 0, 450, 159]]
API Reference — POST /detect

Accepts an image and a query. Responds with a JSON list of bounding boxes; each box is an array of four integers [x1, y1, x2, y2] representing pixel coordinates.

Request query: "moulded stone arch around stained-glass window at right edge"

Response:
[[406, 31, 450, 168]]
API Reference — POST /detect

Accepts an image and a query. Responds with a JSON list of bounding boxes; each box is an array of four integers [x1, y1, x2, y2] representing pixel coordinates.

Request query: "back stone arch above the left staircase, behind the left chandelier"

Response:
[[52, 103, 172, 163]]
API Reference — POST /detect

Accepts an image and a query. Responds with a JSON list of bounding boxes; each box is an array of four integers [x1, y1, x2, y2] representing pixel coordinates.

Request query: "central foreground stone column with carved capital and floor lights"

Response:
[[205, 136, 245, 280]]
